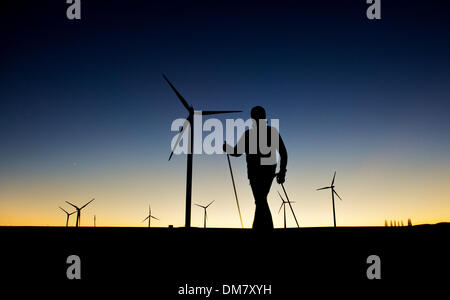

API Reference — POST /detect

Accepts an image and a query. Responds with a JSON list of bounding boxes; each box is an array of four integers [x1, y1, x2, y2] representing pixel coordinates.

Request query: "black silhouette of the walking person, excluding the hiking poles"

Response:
[[223, 106, 287, 230]]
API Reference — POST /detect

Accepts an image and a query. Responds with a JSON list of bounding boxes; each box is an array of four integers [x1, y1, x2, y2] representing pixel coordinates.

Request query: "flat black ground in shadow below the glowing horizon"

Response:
[[0, 223, 450, 299]]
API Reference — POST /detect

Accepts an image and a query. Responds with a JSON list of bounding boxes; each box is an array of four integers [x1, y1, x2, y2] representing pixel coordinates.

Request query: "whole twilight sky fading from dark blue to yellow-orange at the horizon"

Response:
[[0, 0, 450, 227]]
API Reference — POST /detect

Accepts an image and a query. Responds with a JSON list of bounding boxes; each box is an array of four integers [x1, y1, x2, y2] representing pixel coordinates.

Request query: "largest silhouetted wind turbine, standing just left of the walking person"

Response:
[[163, 74, 242, 228]]
